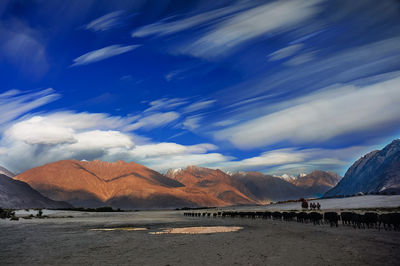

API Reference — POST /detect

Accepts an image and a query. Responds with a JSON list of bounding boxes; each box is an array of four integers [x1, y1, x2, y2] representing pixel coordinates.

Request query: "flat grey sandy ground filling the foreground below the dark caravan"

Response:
[[0, 211, 400, 265]]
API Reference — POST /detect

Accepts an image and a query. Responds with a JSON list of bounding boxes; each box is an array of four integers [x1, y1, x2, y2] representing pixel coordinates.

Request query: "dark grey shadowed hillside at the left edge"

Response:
[[0, 174, 71, 209]]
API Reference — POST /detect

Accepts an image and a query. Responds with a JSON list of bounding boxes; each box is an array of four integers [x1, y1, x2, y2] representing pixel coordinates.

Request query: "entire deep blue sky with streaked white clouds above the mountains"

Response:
[[0, 0, 400, 175]]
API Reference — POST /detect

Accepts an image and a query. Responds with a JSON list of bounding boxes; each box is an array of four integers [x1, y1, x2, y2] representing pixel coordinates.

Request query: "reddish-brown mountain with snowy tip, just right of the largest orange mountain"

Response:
[[166, 166, 257, 205]]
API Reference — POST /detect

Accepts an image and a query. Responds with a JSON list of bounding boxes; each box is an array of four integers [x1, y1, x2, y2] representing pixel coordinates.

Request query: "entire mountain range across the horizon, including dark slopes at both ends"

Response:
[[0, 140, 400, 209]]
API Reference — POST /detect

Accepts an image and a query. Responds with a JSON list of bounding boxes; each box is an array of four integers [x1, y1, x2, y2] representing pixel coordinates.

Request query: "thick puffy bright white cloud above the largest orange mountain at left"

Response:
[[0, 112, 136, 171]]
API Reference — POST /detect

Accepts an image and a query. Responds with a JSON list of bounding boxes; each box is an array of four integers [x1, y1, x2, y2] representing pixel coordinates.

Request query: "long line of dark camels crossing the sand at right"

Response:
[[184, 209, 400, 231]]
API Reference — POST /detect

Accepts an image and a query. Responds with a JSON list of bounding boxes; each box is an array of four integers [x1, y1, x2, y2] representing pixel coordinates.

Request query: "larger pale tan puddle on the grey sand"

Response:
[[149, 226, 243, 235]]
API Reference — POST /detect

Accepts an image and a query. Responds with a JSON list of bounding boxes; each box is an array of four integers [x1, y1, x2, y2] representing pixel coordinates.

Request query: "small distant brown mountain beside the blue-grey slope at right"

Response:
[[291, 170, 342, 197]]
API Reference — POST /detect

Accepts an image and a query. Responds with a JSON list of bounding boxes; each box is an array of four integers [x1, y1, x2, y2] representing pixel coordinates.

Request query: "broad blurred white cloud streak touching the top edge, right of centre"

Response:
[[178, 0, 319, 58]]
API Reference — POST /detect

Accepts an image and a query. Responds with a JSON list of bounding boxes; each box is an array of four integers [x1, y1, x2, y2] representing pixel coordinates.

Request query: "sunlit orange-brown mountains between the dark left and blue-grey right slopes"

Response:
[[9, 160, 340, 209]]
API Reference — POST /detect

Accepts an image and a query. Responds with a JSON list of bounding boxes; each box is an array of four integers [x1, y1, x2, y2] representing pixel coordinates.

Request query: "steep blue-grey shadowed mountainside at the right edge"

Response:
[[324, 139, 400, 197]]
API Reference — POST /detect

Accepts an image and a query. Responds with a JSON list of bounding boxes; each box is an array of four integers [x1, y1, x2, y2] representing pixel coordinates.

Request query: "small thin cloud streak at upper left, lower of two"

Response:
[[71, 44, 140, 66]]
